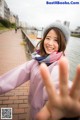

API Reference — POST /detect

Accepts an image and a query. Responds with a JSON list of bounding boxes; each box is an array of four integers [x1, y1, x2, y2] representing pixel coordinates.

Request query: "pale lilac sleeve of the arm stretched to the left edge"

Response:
[[0, 60, 33, 94]]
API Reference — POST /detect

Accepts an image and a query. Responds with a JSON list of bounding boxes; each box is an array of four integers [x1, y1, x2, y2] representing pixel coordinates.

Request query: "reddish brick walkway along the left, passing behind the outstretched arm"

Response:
[[0, 30, 29, 120]]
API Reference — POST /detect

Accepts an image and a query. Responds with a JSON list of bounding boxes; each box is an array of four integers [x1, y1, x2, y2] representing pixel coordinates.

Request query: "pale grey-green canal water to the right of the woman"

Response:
[[66, 37, 80, 80]]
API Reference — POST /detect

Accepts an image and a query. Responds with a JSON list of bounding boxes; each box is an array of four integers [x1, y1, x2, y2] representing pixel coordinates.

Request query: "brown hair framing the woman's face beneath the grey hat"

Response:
[[38, 27, 67, 56]]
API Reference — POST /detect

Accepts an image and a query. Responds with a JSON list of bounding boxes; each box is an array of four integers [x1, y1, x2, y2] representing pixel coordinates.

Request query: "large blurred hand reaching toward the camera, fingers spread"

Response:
[[36, 57, 80, 120]]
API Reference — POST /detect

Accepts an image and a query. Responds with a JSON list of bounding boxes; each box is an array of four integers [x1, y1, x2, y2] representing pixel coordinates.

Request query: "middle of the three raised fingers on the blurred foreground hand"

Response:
[[59, 57, 69, 96]]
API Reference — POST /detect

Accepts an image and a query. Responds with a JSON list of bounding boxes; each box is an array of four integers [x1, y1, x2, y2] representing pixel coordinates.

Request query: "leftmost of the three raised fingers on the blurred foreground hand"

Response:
[[40, 63, 57, 100]]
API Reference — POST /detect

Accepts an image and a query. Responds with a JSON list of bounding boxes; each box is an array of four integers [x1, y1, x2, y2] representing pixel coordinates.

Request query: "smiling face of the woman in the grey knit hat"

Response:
[[44, 30, 59, 54]]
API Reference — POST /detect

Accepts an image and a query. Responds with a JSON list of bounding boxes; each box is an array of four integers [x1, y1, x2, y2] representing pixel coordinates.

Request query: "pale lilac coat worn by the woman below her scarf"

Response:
[[0, 59, 71, 120]]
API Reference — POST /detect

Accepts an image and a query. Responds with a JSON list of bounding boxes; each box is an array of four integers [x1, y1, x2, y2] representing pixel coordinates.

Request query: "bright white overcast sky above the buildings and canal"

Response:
[[5, 0, 80, 30]]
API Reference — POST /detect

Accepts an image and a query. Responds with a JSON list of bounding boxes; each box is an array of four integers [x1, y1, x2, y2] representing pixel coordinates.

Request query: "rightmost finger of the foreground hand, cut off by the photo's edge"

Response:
[[70, 65, 80, 99]]
